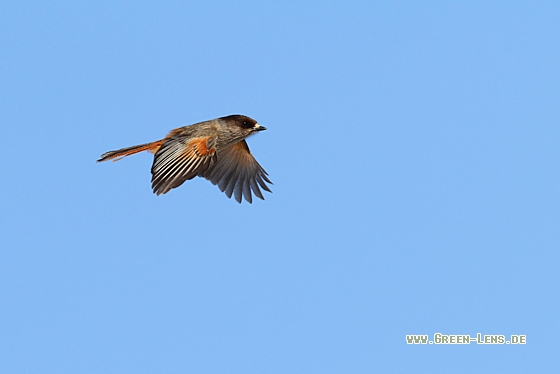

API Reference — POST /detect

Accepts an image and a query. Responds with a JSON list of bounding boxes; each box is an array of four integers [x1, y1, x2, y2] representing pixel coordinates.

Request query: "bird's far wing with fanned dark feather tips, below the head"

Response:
[[199, 140, 272, 204]]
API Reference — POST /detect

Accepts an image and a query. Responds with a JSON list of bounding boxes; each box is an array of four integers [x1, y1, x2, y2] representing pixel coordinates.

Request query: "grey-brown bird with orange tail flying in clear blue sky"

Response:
[[97, 114, 272, 204]]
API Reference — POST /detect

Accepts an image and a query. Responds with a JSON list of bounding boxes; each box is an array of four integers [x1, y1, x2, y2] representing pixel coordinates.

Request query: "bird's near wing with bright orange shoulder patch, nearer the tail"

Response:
[[152, 136, 216, 195]]
